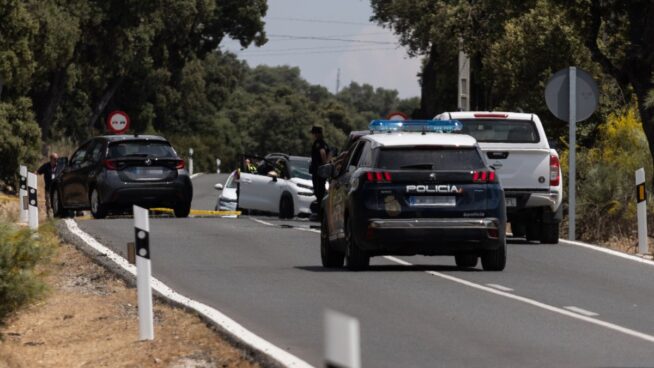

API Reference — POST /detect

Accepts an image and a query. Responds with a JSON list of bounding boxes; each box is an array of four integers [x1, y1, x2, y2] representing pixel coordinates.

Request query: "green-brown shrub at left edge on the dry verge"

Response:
[[0, 220, 57, 325]]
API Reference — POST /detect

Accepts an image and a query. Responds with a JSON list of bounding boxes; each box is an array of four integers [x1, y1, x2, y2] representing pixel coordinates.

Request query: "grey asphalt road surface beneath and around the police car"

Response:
[[72, 175, 654, 367]]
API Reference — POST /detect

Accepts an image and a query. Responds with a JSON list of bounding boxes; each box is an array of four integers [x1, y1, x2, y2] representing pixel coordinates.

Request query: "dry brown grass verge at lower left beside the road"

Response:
[[0, 194, 258, 368]]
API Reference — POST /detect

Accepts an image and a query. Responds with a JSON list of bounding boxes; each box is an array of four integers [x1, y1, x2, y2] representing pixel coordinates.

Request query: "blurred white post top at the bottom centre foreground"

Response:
[[325, 310, 361, 368]]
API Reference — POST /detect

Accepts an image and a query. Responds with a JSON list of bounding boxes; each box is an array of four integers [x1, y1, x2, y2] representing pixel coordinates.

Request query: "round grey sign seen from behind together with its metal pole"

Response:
[[545, 66, 599, 240]]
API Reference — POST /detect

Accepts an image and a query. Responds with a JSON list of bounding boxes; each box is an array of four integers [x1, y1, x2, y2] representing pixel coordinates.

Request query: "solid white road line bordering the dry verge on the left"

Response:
[[65, 219, 312, 367]]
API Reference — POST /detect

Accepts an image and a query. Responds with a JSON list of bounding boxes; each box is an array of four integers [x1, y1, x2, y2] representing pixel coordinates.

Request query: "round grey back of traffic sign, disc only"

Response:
[[545, 68, 599, 123]]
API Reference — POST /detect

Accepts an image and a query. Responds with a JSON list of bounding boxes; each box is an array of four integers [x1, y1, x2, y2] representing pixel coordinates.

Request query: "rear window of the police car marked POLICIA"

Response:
[[376, 147, 484, 170]]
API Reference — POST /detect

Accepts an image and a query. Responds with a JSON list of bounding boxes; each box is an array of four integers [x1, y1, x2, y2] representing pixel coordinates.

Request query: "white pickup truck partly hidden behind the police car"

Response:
[[435, 111, 563, 244]]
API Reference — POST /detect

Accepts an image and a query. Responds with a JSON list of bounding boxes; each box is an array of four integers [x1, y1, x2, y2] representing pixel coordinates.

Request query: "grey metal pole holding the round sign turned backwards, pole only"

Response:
[[568, 66, 577, 240]]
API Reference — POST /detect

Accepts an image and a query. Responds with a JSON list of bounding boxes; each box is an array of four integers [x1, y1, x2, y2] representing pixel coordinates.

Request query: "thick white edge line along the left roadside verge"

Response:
[[59, 219, 313, 368]]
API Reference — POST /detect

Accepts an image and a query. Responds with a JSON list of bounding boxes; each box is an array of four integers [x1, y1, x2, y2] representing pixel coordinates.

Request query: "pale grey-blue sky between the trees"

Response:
[[221, 0, 421, 98]]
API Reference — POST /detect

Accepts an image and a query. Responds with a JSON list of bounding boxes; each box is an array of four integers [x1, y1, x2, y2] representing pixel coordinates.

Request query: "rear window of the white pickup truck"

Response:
[[459, 119, 540, 143]]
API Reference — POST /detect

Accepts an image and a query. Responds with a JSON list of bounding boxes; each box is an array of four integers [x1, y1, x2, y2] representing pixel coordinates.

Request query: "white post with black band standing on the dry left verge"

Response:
[[134, 206, 154, 340]]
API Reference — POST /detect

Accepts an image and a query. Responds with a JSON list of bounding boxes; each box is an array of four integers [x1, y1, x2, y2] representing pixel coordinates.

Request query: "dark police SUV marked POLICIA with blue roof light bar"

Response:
[[319, 120, 506, 271]]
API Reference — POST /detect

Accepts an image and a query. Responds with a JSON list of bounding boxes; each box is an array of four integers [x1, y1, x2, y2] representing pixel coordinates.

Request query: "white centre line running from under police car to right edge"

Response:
[[384, 256, 654, 343]]
